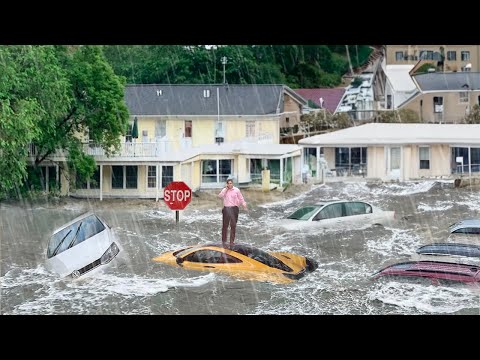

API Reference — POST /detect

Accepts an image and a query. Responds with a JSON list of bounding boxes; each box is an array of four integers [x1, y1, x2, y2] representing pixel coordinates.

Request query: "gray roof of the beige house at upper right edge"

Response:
[[413, 72, 480, 92]]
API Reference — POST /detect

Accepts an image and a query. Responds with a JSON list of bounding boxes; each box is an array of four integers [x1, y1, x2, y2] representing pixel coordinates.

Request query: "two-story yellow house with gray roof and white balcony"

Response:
[[70, 84, 307, 200]]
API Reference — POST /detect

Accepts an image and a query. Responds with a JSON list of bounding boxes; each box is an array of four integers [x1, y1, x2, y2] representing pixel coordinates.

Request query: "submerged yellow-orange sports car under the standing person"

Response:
[[152, 243, 318, 283]]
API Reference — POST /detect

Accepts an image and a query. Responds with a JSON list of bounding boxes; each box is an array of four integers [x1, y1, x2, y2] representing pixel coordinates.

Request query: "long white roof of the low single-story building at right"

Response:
[[298, 123, 480, 146]]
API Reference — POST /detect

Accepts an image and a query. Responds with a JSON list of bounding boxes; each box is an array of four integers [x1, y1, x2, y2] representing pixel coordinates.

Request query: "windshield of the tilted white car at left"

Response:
[[47, 214, 105, 258]]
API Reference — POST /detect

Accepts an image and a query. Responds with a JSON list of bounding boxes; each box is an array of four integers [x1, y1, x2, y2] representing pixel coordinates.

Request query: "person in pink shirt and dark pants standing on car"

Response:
[[218, 178, 247, 246]]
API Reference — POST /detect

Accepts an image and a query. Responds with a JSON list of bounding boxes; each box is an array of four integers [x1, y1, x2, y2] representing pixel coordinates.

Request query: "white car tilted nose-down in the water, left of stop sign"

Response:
[[46, 212, 121, 279]]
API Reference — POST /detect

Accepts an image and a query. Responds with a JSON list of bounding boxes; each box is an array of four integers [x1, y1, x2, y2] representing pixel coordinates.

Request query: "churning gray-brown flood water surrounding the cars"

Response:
[[0, 181, 480, 315]]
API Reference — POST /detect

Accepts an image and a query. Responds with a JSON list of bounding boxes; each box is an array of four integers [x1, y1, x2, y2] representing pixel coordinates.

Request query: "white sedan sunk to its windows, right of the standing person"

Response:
[[279, 200, 395, 230]]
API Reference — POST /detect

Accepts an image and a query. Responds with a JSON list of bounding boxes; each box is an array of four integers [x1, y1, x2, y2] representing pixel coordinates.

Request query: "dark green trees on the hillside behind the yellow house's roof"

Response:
[[104, 45, 372, 88]]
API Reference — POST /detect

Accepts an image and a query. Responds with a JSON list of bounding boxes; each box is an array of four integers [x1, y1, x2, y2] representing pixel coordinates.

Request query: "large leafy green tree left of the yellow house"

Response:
[[0, 45, 128, 197]]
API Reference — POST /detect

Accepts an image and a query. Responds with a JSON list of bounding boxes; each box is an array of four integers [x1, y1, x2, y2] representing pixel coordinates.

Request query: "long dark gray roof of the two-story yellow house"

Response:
[[125, 84, 306, 116]]
